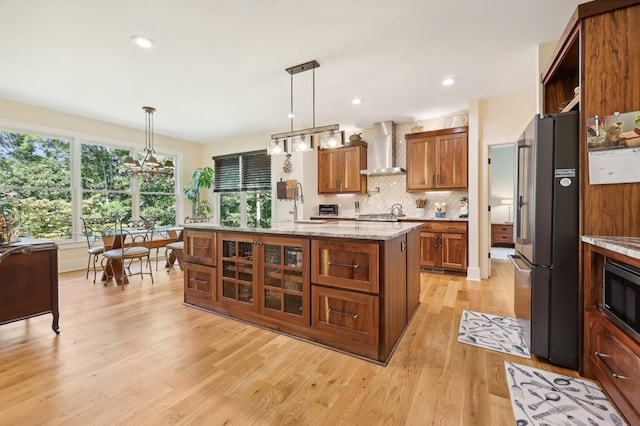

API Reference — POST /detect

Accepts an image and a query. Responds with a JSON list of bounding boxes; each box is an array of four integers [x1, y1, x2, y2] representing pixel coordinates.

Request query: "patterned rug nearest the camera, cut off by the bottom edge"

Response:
[[504, 361, 627, 426]]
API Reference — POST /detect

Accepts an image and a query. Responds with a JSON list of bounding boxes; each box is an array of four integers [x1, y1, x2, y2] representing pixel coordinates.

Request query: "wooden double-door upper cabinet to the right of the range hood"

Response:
[[405, 127, 468, 192]]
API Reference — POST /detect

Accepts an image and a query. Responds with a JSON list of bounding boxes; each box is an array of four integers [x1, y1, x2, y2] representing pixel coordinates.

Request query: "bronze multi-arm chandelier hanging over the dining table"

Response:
[[122, 107, 175, 181]]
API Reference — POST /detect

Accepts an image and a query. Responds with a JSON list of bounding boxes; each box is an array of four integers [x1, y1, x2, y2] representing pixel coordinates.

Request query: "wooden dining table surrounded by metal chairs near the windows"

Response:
[[101, 226, 183, 285]]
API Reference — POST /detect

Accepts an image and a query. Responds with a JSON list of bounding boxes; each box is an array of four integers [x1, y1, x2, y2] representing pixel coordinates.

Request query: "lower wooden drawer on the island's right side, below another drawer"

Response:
[[311, 285, 378, 347]]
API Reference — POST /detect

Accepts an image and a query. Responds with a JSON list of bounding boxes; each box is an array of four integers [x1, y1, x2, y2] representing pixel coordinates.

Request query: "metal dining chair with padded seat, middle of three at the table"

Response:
[[102, 216, 154, 290]]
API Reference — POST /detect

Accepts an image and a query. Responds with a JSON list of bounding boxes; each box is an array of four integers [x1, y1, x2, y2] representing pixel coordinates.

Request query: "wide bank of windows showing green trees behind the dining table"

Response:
[[0, 129, 178, 241]]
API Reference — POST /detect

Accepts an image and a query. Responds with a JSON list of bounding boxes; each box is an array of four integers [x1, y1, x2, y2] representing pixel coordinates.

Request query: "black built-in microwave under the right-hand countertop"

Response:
[[602, 262, 640, 343]]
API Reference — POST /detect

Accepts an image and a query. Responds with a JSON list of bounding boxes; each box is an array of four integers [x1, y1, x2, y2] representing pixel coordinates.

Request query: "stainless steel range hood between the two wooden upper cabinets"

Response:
[[360, 121, 405, 176]]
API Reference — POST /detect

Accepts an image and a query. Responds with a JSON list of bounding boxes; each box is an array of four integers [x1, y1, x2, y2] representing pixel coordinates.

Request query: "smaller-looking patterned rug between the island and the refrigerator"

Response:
[[458, 311, 531, 358]]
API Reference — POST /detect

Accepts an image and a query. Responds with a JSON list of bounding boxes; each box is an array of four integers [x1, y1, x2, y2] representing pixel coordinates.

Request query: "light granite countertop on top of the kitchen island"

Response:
[[184, 220, 421, 240]]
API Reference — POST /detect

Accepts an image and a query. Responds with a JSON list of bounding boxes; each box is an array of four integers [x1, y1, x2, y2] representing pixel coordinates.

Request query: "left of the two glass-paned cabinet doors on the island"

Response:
[[218, 233, 258, 310]]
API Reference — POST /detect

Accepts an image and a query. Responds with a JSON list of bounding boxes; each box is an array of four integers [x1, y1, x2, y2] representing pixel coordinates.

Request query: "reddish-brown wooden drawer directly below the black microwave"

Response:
[[588, 314, 640, 417]]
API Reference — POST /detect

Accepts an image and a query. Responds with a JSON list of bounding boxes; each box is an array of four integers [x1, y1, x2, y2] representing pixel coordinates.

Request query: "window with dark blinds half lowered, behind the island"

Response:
[[213, 150, 271, 228]]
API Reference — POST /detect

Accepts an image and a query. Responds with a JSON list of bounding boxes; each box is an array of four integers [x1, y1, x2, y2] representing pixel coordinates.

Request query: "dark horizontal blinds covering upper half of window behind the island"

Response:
[[213, 150, 271, 192]]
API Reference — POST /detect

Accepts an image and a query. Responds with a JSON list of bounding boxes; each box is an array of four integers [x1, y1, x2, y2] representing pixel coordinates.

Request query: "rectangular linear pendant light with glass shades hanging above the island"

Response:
[[267, 60, 340, 154]]
